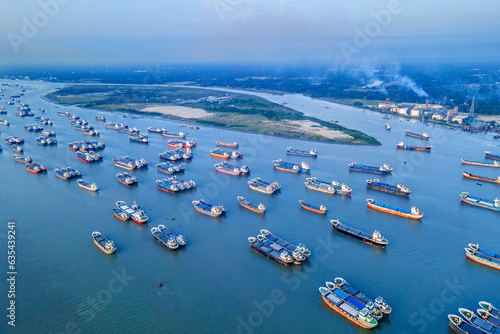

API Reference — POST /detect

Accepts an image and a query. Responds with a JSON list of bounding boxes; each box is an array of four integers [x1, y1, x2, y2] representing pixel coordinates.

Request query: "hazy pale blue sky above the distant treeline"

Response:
[[0, 0, 500, 65]]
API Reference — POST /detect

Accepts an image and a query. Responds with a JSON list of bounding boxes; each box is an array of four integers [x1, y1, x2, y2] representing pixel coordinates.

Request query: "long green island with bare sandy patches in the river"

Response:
[[46, 84, 380, 145]]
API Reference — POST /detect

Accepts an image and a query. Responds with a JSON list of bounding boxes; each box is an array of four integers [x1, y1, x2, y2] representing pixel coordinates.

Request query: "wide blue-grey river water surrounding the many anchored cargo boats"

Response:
[[0, 80, 500, 333]]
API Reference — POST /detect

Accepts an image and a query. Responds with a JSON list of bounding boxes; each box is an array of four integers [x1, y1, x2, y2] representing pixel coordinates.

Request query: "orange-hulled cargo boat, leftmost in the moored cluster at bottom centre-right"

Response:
[[319, 287, 378, 329]]
